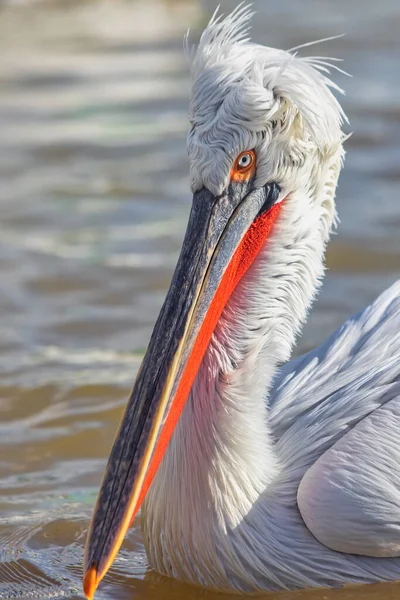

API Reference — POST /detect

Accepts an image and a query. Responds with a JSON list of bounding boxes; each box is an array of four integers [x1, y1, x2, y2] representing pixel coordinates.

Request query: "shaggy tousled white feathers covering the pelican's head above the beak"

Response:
[[185, 4, 346, 193]]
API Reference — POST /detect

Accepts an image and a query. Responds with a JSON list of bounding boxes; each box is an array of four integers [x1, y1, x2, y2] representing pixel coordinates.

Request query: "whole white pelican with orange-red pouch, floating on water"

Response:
[[84, 6, 400, 599]]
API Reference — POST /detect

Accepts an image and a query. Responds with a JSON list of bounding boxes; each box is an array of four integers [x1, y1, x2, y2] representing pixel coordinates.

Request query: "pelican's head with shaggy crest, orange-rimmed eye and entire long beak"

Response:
[[84, 7, 344, 598]]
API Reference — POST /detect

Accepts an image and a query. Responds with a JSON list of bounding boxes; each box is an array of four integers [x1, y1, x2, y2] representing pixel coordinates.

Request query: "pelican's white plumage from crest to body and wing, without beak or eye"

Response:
[[142, 8, 400, 591]]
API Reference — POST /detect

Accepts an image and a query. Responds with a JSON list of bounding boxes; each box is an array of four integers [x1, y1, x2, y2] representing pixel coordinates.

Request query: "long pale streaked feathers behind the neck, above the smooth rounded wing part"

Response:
[[269, 280, 400, 467]]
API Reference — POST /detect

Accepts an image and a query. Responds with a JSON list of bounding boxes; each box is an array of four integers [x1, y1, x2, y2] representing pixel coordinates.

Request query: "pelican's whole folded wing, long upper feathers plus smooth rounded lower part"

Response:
[[269, 281, 400, 557]]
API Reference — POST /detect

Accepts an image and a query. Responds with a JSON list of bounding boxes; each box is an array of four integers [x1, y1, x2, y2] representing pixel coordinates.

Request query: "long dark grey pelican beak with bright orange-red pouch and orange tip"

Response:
[[83, 182, 280, 599]]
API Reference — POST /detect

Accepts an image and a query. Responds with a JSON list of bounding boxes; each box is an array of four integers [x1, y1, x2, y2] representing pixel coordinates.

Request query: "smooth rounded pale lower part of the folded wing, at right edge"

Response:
[[297, 397, 400, 557]]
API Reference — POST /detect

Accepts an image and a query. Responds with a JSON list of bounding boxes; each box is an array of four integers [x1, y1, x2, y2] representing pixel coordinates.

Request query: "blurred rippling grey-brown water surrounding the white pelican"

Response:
[[0, 0, 400, 600]]
